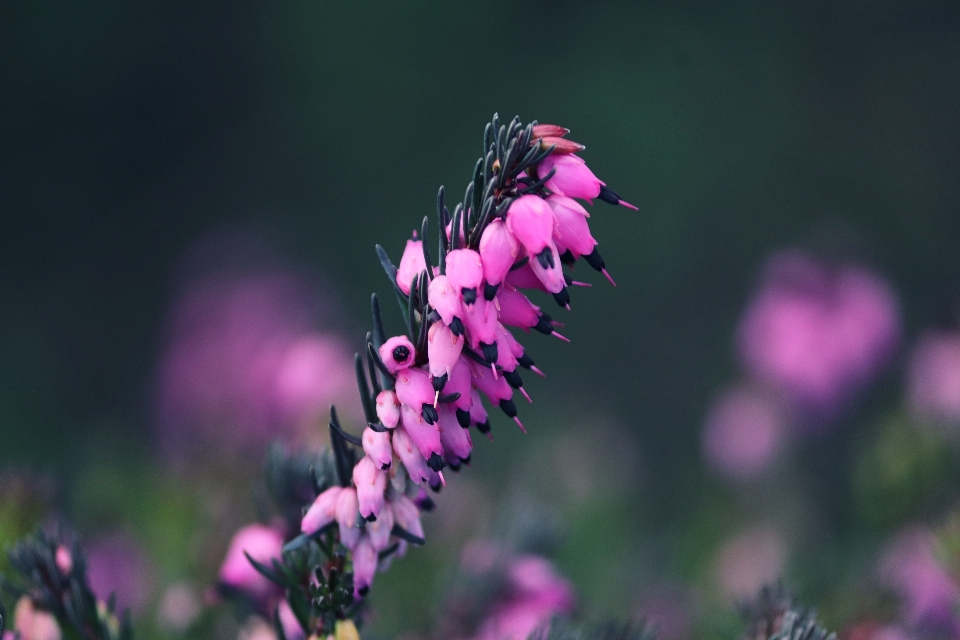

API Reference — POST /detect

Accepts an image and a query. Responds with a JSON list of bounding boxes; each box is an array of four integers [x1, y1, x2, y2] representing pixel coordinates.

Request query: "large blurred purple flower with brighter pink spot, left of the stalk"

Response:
[[156, 232, 356, 454]]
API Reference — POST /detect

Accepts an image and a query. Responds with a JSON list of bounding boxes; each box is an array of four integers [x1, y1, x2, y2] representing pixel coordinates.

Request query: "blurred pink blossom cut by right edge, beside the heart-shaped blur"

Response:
[[908, 331, 960, 423]]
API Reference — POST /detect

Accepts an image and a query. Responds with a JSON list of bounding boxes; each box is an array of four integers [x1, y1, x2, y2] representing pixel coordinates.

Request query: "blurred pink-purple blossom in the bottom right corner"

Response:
[[880, 527, 960, 632]]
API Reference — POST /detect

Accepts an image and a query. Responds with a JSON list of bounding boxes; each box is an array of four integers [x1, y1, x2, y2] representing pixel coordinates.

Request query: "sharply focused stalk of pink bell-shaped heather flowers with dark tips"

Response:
[[262, 116, 636, 638]]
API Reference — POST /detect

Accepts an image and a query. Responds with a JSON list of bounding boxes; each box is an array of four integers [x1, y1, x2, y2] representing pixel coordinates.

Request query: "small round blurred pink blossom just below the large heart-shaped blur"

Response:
[[702, 385, 786, 480]]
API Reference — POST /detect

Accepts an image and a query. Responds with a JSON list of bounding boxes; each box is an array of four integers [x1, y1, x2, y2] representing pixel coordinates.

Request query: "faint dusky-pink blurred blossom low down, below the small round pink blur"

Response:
[[715, 525, 787, 600]]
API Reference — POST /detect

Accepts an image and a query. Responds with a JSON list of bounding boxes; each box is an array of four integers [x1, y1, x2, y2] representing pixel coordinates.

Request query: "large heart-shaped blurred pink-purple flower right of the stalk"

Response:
[[738, 250, 900, 417]]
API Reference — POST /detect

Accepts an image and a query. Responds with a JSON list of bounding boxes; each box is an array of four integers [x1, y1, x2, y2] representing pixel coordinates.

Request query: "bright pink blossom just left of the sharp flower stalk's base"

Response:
[[221, 524, 283, 602]]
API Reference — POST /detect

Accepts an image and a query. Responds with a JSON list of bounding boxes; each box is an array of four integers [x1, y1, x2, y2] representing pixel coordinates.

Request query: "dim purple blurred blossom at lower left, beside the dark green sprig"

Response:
[[85, 532, 153, 617]]
